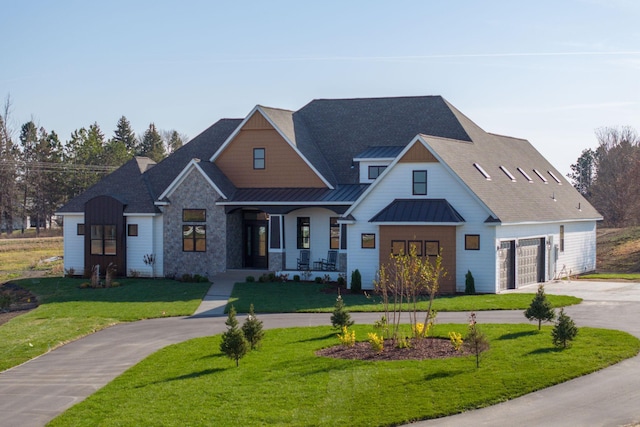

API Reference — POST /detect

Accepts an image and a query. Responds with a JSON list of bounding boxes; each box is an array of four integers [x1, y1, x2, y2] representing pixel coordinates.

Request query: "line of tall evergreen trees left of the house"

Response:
[[0, 97, 187, 234]]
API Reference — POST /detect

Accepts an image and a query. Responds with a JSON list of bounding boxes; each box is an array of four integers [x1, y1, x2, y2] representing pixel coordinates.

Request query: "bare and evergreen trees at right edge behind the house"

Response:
[[568, 126, 640, 227]]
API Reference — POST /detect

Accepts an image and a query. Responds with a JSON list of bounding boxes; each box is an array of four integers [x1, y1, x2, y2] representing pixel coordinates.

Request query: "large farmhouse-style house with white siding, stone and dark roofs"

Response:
[[57, 96, 601, 293]]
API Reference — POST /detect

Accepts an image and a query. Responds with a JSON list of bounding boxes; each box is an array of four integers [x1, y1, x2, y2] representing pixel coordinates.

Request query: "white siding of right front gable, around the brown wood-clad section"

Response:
[[347, 159, 496, 292]]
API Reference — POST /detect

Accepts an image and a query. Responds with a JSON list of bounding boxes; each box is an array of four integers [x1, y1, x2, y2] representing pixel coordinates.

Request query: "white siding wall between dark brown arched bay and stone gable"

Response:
[[127, 216, 162, 277]]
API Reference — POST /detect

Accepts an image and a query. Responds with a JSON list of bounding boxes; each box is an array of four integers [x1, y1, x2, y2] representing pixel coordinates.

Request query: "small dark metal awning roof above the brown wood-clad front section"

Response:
[[369, 199, 464, 223]]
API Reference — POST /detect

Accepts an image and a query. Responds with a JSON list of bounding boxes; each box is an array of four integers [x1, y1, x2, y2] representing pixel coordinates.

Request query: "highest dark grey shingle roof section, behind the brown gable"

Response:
[[293, 96, 471, 185]]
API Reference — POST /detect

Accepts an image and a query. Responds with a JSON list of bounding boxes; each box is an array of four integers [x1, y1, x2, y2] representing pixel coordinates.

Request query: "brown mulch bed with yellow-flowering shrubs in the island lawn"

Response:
[[316, 338, 469, 361]]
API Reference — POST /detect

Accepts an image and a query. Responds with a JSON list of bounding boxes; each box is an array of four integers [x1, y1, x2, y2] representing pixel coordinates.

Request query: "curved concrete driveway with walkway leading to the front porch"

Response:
[[0, 274, 640, 427]]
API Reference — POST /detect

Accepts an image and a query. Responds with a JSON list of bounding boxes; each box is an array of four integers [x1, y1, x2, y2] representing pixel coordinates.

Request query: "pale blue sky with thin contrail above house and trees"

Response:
[[0, 0, 640, 173]]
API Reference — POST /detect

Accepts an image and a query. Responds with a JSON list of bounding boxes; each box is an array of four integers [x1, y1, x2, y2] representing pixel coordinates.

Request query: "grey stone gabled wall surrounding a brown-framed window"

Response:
[[163, 170, 227, 278]]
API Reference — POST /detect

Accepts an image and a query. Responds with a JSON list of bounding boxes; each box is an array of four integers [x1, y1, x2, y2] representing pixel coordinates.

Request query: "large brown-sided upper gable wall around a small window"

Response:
[[215, 111, 326, 188]]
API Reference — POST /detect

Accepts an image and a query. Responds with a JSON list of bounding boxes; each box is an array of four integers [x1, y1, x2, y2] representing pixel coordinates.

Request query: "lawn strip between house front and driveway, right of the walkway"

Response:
[[229, 282, 582, 313]]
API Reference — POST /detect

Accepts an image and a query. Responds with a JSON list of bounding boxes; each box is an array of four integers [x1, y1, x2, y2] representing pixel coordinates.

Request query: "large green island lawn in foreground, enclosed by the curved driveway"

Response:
[[50, 324, 640, 426]]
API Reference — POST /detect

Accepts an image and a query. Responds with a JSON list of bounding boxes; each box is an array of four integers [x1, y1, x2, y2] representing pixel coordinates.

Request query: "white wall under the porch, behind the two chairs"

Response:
[[284, 208, 340, 270]]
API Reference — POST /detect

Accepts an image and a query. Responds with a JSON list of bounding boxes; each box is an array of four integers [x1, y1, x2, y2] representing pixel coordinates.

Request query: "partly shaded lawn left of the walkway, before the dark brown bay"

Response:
[[0, 278, 210, 371]]
